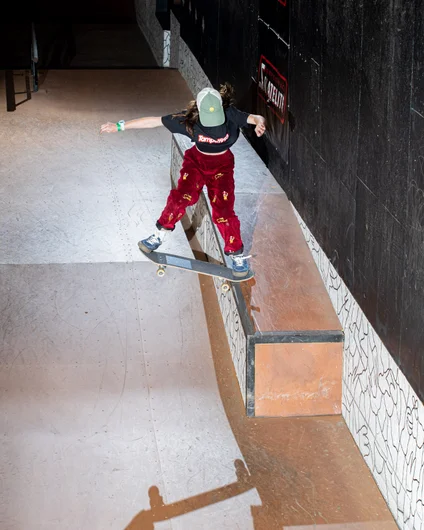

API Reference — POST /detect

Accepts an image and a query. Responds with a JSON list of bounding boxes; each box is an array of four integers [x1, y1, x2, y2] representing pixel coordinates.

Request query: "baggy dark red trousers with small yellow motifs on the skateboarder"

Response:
[[158, 146, 243, 254]]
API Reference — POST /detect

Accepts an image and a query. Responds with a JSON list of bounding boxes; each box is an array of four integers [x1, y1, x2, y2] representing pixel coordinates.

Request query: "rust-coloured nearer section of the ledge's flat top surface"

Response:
[[243, 194, 341, 331]]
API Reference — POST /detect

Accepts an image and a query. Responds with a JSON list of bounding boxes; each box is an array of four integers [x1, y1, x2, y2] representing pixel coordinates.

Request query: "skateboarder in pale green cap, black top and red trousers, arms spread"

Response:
[[101, 83, 265, 277]]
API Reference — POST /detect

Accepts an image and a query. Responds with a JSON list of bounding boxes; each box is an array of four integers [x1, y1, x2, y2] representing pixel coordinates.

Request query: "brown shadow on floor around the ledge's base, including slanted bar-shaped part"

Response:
[[126, 276, 397, 530]]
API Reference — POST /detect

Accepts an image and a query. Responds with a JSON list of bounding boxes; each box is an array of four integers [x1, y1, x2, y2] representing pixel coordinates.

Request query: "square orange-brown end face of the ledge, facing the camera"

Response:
[[255, 343, 342, 417]]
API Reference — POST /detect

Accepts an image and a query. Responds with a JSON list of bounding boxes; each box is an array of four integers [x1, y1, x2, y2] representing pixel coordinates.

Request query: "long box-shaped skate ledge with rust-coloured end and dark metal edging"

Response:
[[171, 135, 343, 416]]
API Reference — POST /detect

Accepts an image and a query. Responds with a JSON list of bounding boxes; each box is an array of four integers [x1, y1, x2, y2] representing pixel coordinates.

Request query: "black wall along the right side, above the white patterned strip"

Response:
[[172, 0, 424, 399]]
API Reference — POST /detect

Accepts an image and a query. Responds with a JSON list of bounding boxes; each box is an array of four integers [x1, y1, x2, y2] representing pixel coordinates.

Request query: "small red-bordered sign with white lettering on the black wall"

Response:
[[258, 55, 288, 123]]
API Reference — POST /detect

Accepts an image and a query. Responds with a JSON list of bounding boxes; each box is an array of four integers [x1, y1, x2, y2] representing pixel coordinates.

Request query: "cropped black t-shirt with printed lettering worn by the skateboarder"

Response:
[[162, 106, 249, 153]]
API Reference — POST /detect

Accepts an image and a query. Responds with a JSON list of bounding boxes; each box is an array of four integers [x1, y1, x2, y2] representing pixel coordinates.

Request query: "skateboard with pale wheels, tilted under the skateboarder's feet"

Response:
[[139, 247, 255, 293]]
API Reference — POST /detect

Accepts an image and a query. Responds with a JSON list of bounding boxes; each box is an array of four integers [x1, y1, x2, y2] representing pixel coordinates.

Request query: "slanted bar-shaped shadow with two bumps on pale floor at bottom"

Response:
[[125, 460, 254, 530]]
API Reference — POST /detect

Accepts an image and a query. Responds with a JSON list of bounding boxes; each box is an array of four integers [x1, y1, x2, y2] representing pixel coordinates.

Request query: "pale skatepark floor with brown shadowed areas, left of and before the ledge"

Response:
[[0, 70, 396, 530]]
